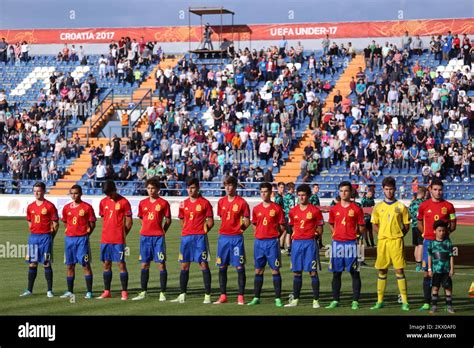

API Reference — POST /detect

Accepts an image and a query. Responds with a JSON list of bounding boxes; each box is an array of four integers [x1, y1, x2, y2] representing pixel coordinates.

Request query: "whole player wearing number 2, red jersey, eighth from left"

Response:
[[285, 184, 324, 308]]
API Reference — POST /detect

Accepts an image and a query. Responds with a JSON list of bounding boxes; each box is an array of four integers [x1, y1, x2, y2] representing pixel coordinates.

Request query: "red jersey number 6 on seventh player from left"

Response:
[[252, 202, 285, 239]]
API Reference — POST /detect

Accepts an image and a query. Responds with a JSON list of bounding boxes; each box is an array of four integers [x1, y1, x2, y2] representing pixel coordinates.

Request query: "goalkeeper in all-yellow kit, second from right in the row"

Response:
[[371, 177, 410, 311]]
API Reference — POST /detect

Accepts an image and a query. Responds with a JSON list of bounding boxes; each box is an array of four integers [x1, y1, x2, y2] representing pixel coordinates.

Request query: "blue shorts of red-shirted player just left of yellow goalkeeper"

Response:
[[329, 240, 359, 272]]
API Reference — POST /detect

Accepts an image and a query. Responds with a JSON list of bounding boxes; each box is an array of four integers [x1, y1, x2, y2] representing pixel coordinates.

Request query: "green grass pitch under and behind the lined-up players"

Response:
[[0, 218, 474, 316]]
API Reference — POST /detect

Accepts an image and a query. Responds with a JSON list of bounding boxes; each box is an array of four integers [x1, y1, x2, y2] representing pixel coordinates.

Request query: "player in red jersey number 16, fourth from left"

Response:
[[132, 178, 171, 302]]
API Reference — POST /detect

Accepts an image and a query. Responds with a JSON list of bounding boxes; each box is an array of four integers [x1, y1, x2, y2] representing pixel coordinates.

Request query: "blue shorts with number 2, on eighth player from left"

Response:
[[291, 239, 319, 272]]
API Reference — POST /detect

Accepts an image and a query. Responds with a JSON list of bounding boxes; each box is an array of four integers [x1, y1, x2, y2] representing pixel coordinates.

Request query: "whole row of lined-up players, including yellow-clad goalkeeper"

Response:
[[20, 176, 466, 311]]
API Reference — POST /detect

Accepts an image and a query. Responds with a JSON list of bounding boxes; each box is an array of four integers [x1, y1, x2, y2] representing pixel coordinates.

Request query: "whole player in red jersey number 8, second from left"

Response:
[[61, 185, 97, 299]]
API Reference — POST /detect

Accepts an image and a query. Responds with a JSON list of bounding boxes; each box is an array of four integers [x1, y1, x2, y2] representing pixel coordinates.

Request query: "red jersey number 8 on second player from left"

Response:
[[62, 202, 97, 237]]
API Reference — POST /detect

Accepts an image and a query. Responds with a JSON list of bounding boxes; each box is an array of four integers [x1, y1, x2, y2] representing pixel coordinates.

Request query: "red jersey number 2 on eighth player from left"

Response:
[[288, 204, 324, 239]]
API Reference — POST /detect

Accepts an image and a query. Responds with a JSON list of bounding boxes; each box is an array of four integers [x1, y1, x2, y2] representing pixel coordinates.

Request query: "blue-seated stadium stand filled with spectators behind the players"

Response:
[[0, 37, 474, 199]]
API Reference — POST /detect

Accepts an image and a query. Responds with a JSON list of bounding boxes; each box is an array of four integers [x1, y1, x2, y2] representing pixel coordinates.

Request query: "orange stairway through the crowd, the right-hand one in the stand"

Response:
[[275, 55, 365, 182]]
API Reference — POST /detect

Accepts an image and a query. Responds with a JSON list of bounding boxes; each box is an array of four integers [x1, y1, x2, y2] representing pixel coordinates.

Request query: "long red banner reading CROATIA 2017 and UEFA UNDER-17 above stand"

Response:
[[0, 18, 474, 44]]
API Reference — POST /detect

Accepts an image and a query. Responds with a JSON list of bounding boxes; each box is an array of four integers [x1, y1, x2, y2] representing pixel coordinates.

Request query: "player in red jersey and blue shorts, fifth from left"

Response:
[[171, 178, 214, 304]]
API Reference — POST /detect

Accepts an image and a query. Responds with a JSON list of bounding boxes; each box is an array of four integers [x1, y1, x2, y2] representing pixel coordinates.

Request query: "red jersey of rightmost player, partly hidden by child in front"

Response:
[[418, 199, 456, 240]]
